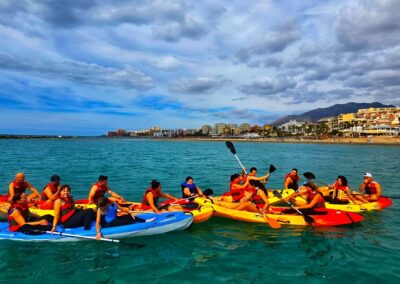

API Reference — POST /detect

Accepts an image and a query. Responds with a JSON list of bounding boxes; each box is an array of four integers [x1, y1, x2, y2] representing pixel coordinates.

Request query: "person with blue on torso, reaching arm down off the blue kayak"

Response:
[[96, 196, 148, 240]]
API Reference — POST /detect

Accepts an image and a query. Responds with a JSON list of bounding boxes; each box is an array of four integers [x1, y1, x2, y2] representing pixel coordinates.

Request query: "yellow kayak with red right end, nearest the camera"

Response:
[[195, 198, 363, 227]]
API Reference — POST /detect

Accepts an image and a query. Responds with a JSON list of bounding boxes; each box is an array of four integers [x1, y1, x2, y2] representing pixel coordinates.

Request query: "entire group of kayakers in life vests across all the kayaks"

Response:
[[3, 167, 382, 238]]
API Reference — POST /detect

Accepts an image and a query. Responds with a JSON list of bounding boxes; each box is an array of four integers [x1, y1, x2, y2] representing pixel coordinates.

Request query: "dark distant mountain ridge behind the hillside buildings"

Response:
[[272, 102, 394, 126]]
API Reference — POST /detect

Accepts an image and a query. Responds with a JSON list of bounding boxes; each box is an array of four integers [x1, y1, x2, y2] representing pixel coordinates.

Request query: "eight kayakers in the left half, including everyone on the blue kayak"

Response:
[[4, 173, 203, 238]]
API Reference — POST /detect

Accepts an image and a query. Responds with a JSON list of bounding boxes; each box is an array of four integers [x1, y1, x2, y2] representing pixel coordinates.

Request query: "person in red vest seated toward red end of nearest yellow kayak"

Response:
[[283, 182, 326, 214]]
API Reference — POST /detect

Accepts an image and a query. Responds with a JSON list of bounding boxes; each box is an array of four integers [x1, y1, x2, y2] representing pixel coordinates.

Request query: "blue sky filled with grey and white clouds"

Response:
[[0, 0, 400, 135]]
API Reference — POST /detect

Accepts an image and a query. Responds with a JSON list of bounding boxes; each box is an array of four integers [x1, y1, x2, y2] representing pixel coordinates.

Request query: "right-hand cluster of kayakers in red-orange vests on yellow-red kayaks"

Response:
[[223, 167, 382, 213]]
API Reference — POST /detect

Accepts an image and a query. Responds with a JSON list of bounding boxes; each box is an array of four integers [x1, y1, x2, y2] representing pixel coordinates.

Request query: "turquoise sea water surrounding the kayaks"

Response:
[[0, 139, 400, 283]]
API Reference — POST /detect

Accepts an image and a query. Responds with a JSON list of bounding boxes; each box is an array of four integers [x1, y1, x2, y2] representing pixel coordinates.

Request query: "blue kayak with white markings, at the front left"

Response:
[[0, 212, 193, 241]]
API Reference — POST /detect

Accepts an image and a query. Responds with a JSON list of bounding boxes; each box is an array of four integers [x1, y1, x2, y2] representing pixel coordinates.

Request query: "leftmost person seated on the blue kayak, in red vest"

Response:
[[7, 192, 53, 235]]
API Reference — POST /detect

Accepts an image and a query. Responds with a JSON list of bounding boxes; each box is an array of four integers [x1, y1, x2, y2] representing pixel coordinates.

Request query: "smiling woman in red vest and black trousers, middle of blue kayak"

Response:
[[51, 184, 95, 232]]
